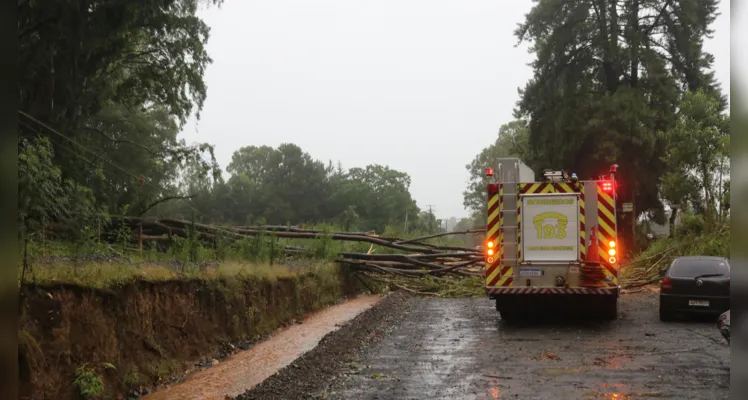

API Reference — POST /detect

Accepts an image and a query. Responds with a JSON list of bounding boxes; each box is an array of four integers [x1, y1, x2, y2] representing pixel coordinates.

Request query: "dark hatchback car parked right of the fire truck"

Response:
[[660, 257, 730, 321]]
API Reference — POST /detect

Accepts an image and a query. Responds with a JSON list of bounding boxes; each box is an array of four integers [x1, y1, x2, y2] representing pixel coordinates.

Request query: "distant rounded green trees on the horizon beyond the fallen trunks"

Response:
[[152, 144, 426, 232]]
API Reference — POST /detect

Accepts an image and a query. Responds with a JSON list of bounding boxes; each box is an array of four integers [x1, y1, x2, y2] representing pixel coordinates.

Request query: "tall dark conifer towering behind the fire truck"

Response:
[[516, 0, 719, 245]]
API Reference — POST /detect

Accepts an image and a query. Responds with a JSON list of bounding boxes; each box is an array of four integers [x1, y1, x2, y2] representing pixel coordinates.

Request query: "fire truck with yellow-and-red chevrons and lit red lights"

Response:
[[483, 158, 620, 320]]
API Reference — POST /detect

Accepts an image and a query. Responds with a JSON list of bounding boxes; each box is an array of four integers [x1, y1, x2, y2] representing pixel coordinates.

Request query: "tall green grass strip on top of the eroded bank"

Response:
[[18, 220, 468, 288]]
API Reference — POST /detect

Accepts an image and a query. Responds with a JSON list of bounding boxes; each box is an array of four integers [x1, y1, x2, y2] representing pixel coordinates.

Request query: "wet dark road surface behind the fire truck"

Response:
[[328, 291, 730, 400]]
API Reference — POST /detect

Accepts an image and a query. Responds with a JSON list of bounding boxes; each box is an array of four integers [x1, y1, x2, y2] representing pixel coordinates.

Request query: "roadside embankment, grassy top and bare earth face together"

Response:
[[18, 225, 480, 399]]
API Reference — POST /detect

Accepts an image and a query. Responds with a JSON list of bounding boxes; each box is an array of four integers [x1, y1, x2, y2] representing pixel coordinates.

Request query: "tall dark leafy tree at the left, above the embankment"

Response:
[[18, 0, 220, 225]]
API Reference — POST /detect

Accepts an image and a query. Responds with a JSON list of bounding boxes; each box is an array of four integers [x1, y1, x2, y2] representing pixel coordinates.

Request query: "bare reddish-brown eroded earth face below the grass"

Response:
[[19, 271, 374, 399]]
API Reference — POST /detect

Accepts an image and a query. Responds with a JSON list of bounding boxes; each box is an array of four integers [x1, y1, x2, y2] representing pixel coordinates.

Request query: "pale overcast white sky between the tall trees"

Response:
[[181, 0, 730, 218]]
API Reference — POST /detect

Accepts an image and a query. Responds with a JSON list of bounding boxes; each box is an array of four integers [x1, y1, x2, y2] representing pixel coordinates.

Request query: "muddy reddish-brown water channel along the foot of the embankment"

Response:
[[143, 296, 381, 400]]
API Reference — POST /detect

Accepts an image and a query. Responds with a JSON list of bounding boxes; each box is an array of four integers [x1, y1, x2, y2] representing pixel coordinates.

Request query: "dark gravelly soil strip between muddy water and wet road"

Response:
[[236, 293, 415, 400]]
